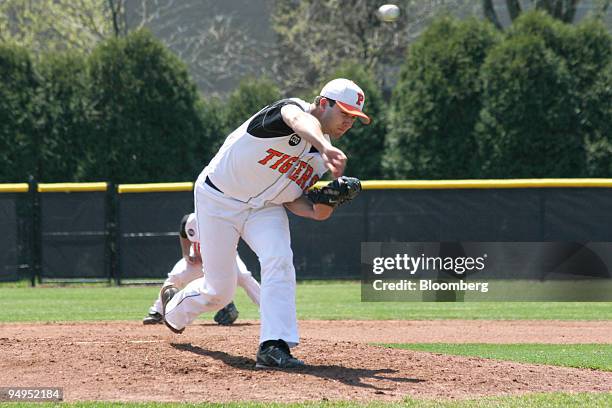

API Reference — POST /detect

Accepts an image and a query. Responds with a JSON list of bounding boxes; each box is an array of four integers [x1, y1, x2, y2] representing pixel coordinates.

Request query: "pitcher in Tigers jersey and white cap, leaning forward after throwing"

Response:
[[161, 78, 370, 368]]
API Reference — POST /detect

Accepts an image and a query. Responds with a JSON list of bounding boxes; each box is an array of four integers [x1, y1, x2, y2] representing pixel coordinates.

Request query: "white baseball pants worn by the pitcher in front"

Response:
[[166, 183, 299, 346]]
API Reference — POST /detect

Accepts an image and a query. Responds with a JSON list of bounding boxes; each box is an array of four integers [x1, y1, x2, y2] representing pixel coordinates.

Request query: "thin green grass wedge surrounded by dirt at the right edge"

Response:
[[382, 343, 612, 371]]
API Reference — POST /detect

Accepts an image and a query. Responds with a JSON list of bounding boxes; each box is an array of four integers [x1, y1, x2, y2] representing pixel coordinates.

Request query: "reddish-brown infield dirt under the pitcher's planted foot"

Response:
[[0, 320, 612, 402]]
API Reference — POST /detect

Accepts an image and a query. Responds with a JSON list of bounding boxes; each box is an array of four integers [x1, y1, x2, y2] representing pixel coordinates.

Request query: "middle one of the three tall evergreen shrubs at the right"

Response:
[[477, 35, 584, 178]]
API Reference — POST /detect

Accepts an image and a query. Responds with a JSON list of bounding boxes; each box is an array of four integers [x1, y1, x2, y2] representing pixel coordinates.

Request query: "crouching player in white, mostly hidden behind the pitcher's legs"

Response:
[[142, 213, 260, 326]]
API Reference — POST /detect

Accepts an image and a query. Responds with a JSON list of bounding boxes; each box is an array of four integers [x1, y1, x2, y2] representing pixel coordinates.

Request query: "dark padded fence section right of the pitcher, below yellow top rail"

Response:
[[290, 188, 612, 279]]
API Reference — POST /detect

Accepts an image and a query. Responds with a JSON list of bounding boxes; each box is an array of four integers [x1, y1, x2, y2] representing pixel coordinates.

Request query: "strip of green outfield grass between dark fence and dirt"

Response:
[[0, 282, 612, 322]]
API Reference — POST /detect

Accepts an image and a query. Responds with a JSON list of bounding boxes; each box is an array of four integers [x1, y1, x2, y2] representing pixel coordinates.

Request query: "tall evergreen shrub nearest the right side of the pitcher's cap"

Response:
[[384, 17, 498, 179]]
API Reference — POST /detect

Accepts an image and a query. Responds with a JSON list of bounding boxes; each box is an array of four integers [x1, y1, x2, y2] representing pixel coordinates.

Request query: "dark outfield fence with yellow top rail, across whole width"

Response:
[[0, 179, 612, 284]]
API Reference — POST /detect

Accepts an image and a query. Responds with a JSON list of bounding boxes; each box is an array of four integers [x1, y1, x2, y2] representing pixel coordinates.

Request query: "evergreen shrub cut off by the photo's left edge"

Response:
[[0, 44, 41, 182]]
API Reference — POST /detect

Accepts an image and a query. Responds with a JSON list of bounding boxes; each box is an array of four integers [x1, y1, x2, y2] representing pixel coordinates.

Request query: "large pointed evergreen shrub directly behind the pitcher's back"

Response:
[[83, 31, 218, 182]]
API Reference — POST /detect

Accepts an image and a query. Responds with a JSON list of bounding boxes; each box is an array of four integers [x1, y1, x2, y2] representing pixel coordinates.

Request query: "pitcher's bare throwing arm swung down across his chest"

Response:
[[281, 104, 346, 178]]
